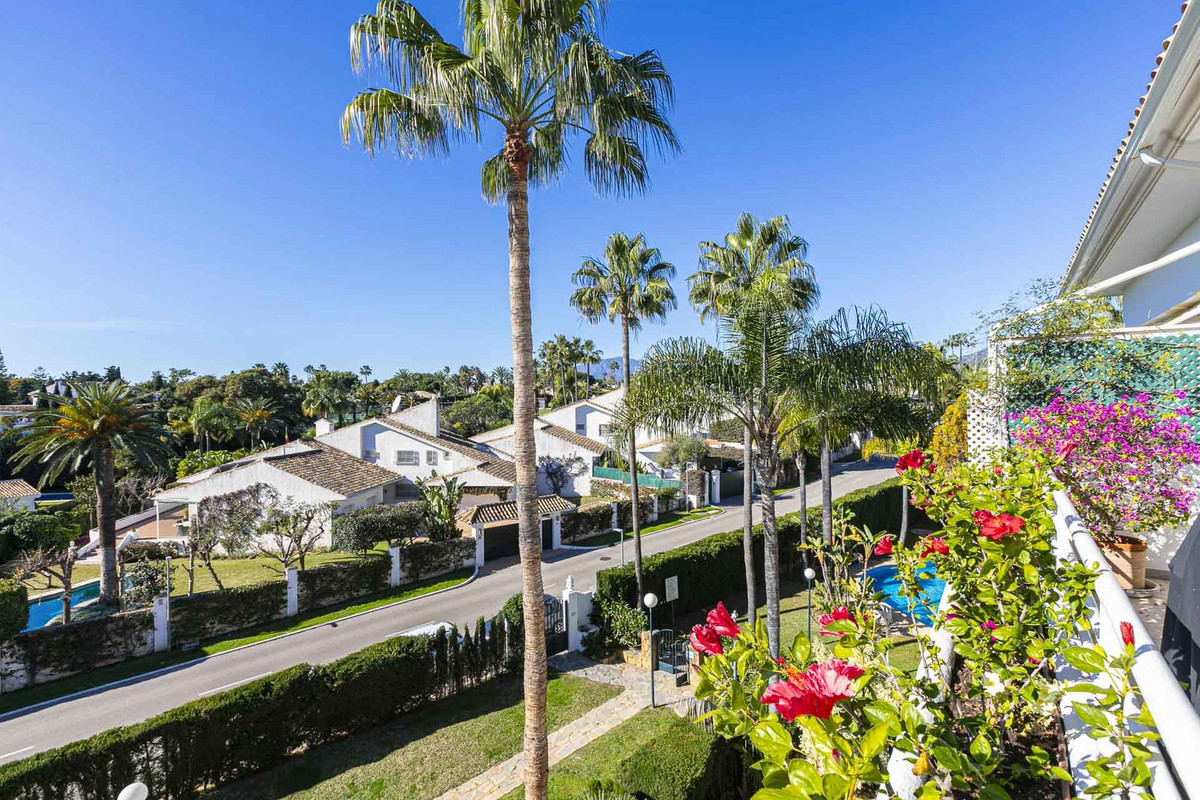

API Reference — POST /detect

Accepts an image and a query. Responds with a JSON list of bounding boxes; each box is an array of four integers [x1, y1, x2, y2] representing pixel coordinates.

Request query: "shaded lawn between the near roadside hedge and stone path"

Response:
[[216, 675, 620, 800]]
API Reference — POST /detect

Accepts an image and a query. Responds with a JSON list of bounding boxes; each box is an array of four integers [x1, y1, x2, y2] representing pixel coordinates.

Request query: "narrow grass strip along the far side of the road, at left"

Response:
[[0, 569, 473, 714]]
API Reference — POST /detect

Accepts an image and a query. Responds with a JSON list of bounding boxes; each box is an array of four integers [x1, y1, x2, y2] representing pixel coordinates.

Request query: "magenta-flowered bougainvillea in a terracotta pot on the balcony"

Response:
[[1010, 391, 1200, 589]]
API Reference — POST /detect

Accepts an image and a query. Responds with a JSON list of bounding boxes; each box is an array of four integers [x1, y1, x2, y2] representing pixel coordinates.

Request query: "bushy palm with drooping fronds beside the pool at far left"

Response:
[[13, 380, 170, 606]]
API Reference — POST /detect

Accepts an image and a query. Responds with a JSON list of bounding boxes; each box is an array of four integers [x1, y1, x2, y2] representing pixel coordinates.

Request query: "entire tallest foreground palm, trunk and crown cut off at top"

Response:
[[342, 0, 679, 800]]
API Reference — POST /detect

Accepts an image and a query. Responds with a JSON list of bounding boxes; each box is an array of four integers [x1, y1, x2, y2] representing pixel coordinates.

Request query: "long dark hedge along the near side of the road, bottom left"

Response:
[[0, 620, 520, 800]]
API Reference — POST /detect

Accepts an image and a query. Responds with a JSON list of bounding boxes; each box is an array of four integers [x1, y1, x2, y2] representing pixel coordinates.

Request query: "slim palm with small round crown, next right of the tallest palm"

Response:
[[571, 233, 678, 608]]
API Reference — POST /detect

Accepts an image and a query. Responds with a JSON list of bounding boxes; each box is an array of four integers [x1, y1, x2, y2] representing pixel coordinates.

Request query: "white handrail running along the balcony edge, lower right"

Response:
[[1054, 491, 1200, 800]]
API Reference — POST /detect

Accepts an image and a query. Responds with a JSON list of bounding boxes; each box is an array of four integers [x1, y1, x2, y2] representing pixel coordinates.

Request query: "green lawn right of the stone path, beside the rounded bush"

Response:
[[504, 709, 710, 800]]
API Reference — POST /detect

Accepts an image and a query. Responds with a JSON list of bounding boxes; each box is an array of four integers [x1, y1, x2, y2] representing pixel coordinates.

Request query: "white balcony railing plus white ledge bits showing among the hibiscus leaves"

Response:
[[1054, 491, 1200, 800]]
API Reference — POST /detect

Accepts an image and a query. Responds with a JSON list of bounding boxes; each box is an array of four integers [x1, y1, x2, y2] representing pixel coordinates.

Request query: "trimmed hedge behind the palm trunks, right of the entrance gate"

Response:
[[593, 479, 929, 627]]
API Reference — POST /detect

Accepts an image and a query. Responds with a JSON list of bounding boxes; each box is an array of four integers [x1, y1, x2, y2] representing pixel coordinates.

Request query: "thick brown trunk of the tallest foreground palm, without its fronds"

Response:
[[504, 137, 550, 800]]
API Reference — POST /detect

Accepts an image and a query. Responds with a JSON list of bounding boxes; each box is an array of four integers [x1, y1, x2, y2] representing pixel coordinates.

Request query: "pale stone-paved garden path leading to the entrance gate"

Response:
[[438, 654, 691, 800]]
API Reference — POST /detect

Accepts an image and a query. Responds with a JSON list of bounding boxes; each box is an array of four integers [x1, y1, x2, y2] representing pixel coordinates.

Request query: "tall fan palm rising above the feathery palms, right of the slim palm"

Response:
[[688, 212, 820, 622]]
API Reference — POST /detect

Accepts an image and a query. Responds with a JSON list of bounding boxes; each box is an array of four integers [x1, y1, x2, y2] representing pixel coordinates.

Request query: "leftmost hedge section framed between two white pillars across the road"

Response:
[[170, 581, 288, 649]]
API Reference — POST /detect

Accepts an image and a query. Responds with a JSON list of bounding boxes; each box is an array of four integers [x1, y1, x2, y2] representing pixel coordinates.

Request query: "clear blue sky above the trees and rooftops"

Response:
[[0, 0, 1178, 378]]
